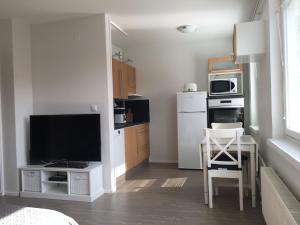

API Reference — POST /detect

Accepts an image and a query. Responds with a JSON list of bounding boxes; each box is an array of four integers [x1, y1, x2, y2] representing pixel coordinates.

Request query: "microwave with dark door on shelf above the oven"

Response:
[[210, 77, 238, 95]]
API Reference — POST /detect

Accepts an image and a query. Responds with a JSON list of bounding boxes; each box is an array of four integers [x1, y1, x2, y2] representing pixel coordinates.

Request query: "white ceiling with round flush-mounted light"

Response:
[[0, 0, 257, 47]]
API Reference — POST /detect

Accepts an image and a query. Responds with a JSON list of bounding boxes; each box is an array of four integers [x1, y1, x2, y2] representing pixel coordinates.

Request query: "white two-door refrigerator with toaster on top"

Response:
[[177, 92, 207, 169]]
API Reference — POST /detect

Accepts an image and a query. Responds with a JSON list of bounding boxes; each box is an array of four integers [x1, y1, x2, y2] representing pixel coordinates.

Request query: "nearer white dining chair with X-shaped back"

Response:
[[206, 128, 244, 211]]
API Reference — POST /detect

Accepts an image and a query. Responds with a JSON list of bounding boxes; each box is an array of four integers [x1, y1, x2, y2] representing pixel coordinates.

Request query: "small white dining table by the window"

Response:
[[200, 135, 258, 208]]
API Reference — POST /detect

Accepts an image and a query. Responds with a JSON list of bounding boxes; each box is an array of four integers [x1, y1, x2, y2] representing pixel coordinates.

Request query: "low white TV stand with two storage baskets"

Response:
[[20, 162, 104, 202]]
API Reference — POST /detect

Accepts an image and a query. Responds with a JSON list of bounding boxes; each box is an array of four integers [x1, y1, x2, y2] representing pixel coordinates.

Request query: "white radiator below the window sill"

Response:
[[261, 167, 300, 225]]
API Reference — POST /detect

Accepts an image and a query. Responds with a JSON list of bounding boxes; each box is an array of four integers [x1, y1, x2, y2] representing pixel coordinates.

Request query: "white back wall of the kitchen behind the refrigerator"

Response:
[[126, 38, 232, 162]]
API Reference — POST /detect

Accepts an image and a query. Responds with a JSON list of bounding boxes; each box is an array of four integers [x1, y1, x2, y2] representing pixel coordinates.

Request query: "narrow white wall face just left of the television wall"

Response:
[[12, 19, 33, 167]]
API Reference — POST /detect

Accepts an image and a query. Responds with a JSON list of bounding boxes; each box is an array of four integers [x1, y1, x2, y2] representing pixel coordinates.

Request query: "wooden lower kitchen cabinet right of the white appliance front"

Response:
[[124, 124, 150, 171]]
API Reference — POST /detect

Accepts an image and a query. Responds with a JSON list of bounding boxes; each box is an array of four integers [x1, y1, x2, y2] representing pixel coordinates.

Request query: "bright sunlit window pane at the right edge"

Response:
[[284, 0, 300, 139]]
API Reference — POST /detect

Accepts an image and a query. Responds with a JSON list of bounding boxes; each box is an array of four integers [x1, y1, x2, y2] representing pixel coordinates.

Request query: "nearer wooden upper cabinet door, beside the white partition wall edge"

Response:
[[112, 59, 128, 99]]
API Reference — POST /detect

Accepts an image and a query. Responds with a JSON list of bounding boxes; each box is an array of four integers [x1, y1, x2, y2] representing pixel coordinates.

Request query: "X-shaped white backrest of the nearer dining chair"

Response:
[[206, 128, 243, 168]]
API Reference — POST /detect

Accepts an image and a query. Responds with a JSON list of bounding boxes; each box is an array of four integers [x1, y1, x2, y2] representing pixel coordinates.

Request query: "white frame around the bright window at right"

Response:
[[281, 0, 300, 141]]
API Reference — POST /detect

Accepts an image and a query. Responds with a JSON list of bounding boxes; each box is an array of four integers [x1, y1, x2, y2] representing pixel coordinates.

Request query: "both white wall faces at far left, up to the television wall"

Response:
[[0, 19, 32, 195]]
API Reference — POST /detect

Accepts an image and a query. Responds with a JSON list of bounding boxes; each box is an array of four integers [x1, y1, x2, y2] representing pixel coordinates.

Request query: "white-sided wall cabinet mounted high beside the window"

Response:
[[233, 21, 266, 64]]
